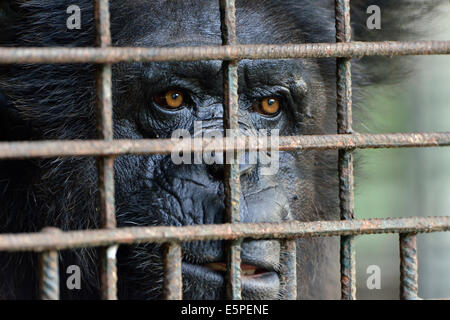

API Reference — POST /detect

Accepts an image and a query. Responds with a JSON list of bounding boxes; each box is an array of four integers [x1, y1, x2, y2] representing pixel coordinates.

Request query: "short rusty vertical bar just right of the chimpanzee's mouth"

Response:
[[280, 240, 297, 300]]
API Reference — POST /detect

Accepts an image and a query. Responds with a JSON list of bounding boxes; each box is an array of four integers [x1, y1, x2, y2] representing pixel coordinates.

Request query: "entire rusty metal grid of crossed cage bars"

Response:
[[0, 0, 450, 299]]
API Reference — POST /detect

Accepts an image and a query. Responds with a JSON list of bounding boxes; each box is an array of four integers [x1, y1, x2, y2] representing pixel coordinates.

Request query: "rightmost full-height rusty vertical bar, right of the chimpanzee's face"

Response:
[[335, 0, 356, 300]]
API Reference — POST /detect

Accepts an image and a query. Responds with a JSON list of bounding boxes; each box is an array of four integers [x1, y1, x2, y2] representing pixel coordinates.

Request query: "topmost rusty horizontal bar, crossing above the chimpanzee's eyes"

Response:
[[0, 41, 450, 64]]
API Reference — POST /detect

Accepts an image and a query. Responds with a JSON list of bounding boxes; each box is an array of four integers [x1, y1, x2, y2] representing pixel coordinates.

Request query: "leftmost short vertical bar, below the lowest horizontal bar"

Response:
[[39, 228, 59, 300]]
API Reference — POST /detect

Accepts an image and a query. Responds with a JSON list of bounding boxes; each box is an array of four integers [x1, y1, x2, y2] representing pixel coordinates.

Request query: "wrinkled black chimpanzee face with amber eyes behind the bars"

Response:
[[108, 1, 335, 299]]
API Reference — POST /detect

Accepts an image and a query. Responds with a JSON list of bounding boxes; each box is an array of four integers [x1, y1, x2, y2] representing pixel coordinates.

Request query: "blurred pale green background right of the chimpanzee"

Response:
[[355, 2, 450, 299]]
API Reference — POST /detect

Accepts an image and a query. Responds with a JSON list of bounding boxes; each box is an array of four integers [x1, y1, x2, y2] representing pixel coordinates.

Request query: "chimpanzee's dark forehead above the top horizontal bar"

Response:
[[111, 0, 301, 46]]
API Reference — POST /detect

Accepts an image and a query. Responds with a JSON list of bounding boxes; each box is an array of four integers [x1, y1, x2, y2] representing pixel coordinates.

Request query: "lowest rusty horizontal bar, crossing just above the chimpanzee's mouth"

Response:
[[0, 216, 450, 252]]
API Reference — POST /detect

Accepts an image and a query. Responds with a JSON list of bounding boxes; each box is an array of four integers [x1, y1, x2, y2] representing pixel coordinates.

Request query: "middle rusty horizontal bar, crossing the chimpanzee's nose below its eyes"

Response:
[[0, 132, 450, 159]]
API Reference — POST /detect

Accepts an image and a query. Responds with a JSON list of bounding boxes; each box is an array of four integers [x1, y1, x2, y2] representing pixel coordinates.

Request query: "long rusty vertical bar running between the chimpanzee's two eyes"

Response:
[[220, 0, 242, 300]]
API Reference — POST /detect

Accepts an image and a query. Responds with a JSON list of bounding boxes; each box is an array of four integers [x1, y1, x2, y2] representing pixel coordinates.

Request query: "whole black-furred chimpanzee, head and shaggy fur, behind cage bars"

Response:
[[0, 0, 430, 299]]
